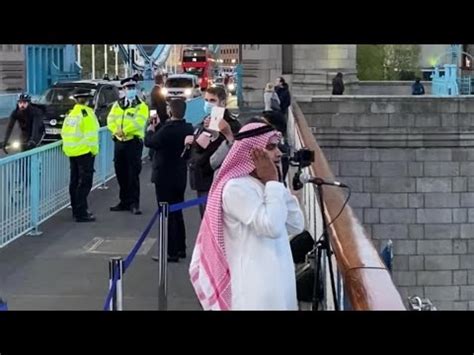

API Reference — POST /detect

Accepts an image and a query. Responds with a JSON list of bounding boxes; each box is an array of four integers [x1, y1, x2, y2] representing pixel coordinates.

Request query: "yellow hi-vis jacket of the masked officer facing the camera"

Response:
[[107, 101, 149, 142]]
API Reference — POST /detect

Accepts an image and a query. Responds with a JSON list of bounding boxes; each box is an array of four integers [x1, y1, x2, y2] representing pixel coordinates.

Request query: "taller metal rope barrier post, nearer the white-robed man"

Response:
[[158, 202, 169, 311]]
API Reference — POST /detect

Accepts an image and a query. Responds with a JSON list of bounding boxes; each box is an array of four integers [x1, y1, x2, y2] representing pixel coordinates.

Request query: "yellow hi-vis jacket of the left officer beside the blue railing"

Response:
[[61, 104, 99, 157]]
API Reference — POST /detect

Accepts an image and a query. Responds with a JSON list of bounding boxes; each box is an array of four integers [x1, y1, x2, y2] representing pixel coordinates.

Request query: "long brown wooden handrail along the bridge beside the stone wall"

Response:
[[292, 103, 406, 310]]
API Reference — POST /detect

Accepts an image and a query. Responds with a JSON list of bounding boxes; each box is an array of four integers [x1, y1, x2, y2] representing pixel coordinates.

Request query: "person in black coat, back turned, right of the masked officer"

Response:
[[145, 100, 194, 262]]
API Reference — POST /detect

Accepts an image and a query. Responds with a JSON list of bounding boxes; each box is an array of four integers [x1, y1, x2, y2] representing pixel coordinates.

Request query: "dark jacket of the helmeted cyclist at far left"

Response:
[[4, 104, 44, 148]]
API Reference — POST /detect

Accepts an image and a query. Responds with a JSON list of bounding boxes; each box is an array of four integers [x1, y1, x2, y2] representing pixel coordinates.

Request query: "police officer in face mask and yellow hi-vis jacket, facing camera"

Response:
[[107, 78, 149, 214]]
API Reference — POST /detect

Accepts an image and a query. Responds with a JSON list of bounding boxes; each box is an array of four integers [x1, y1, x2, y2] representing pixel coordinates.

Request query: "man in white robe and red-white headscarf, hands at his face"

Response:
[[190, 123, 304, 310]]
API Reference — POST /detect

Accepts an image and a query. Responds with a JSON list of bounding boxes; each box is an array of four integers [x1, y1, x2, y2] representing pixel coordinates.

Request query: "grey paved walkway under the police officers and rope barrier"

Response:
[[0, 163, 201, 310]]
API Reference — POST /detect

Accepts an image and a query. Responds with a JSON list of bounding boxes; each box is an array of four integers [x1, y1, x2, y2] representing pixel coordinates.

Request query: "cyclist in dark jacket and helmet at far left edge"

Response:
[[3, 94, 44, 150]]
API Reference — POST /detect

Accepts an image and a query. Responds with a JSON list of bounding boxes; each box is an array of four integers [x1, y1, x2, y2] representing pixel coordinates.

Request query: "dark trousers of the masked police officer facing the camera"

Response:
[[114, 138, 143, 208]]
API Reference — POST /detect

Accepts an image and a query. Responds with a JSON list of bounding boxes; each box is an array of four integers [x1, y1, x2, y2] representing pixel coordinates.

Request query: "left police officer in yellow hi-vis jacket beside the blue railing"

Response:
[[61, 89, 99, 222]]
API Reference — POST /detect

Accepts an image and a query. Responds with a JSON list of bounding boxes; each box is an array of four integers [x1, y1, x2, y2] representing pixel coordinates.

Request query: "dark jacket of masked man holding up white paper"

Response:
[[189, 110, 241, 191]]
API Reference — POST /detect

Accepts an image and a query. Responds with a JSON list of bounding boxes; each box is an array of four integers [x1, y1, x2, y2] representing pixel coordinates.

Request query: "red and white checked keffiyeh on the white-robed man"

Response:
[[189, 123, 279, 310]]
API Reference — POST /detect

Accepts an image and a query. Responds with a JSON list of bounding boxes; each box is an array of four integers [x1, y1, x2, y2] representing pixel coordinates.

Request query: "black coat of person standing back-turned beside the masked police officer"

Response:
[[145, 120, 194, 188]]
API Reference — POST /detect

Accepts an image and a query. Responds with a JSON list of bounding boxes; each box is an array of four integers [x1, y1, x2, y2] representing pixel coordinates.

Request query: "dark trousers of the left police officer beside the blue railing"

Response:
[[69, 153, 95, 218]]
